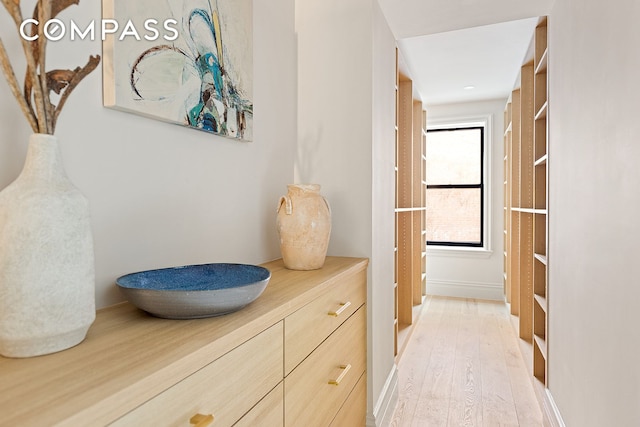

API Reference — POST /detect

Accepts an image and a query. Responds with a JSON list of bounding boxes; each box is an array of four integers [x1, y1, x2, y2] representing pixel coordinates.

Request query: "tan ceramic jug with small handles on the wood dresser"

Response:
[[277, 184, 331, 270]]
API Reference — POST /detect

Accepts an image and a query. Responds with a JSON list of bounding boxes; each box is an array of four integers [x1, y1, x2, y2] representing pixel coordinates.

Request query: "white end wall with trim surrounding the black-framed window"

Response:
[[426, 99, 506, 300]]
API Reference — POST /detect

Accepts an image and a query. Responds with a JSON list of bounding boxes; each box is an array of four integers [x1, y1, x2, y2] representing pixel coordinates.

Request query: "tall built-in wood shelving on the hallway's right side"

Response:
[[504, 17, 549, 392]]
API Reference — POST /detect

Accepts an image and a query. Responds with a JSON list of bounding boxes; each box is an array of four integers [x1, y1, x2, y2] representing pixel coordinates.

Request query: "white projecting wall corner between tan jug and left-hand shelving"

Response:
[[296, 0, 395, 425]]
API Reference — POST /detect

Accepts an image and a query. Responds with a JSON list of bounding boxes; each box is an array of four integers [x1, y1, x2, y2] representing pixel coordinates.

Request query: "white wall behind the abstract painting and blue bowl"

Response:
[[0, 0, 297, 307]]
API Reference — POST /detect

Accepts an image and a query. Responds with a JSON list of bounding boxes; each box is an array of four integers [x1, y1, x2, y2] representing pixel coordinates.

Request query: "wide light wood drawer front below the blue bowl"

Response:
[[113, 322, 283, 427]]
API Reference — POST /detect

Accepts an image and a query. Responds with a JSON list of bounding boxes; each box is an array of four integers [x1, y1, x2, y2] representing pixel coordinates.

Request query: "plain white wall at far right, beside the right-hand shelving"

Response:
[[548, 0, 640, 427]]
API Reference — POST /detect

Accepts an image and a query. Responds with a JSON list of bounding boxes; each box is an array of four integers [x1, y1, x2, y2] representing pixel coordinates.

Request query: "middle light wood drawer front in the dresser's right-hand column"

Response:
[[284, 306, 367, 427]]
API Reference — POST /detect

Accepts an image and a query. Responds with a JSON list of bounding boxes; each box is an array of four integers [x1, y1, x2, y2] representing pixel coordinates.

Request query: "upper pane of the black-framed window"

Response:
[[427, 128, 482, 185]]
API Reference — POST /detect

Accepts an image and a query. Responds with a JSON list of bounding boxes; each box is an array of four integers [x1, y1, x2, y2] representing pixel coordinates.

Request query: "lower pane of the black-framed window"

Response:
[[427, 188, 481, 243]]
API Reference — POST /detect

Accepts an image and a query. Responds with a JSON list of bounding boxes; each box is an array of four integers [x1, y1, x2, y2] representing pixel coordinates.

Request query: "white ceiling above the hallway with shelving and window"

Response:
[[379, 0, 554, 106]]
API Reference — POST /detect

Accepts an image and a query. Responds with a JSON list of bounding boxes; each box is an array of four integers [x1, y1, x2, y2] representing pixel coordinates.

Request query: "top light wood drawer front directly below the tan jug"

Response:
[[284, 270, 367, 374]]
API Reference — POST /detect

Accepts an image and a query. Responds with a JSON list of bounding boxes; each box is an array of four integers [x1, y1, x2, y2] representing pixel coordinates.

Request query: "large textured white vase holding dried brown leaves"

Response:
[[0, 134, 95, 357]]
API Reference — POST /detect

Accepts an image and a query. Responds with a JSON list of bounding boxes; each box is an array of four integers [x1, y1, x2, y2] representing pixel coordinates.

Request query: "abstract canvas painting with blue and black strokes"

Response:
[[101, 0, 253, 141]]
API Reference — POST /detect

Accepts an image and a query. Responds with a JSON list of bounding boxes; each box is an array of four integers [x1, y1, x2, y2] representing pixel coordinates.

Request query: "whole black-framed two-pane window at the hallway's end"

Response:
[[426, 125, 485, 248]]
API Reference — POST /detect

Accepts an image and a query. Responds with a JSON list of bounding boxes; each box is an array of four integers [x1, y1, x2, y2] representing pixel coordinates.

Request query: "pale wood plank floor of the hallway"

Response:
[[391, 297, 543, 427]]
